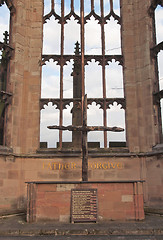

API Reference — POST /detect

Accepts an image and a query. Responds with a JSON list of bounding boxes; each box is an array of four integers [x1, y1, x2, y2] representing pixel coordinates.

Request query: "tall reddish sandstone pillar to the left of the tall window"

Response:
[[5, 0, 43, 154]]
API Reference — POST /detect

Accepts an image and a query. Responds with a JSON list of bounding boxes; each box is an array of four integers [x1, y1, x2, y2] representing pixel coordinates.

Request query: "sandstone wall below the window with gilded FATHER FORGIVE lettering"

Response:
[[0, 154, 163, 213]]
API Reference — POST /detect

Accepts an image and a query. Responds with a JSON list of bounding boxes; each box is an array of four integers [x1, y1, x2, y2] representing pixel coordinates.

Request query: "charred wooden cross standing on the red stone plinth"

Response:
[[48, 95, 124, 181]]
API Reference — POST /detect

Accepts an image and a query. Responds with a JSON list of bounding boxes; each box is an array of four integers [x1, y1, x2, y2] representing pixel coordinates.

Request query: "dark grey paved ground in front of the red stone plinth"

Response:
[[0, 215, 163, 237]]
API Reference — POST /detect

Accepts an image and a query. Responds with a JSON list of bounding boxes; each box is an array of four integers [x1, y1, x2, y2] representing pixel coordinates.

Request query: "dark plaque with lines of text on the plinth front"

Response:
[[71, 189, 97, 223]]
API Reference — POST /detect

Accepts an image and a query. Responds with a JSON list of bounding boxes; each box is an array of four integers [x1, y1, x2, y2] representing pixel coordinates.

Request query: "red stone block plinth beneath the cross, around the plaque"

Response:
[[27, 181, 144, 223]]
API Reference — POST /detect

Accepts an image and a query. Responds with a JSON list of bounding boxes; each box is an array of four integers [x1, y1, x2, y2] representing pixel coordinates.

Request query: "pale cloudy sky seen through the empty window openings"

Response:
[[0, 0, 163, 147]]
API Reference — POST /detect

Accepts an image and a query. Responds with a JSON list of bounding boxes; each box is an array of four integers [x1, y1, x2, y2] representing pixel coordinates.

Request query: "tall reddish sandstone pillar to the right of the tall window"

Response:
[[121, 0, 159, 152]]
